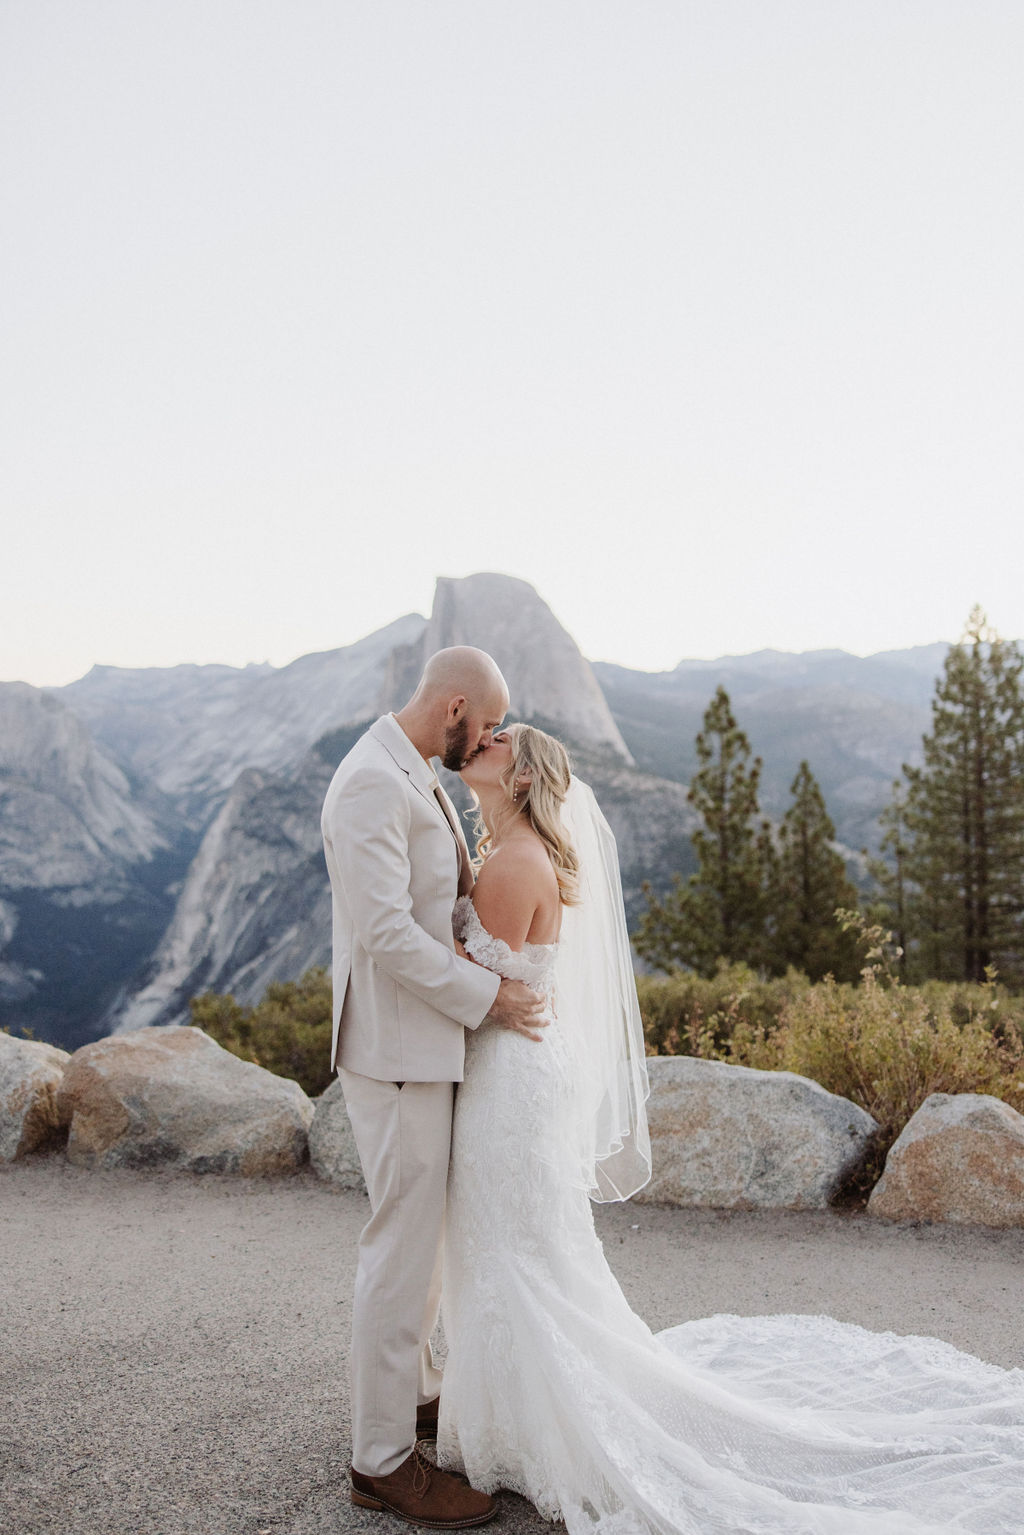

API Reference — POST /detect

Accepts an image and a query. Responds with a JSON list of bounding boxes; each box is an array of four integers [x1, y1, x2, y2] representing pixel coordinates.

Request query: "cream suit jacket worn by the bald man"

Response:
[[321, 714, 500, 1082]]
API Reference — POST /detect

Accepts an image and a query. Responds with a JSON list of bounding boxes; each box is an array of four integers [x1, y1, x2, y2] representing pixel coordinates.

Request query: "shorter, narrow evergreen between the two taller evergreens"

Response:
[[771, 761, 860, 981]]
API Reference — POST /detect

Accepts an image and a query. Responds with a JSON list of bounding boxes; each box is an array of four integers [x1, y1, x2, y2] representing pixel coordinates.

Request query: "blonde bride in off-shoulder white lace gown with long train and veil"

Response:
[[438, 725, 1024, 1535]]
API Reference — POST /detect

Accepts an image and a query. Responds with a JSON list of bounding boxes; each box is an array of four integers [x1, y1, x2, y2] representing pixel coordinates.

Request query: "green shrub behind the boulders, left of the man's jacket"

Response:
[[189, 967, 333, 1098]]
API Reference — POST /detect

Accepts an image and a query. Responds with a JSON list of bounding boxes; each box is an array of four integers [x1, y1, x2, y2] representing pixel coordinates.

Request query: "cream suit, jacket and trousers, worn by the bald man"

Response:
[[321, 714, 499, 1477]]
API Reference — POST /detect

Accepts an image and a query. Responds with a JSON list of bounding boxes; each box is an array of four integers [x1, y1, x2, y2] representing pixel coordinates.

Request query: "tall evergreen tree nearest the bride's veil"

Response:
[[634, 686, 772, 975]]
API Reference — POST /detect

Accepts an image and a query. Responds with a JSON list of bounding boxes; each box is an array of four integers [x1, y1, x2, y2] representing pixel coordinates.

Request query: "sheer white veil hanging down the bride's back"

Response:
[[554, 777, 651, 1202]]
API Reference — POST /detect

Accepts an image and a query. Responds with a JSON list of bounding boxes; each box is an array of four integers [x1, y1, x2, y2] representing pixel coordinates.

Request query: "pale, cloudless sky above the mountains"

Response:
[[0, 0, 1024, 685]]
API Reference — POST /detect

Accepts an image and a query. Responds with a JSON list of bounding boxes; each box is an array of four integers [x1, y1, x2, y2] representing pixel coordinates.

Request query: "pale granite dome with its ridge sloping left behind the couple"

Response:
[[58, 576, 629, 826]]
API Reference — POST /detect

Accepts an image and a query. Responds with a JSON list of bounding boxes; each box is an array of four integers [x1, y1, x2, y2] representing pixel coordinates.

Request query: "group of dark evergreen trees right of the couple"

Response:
[[634, 609, 1024, 990]]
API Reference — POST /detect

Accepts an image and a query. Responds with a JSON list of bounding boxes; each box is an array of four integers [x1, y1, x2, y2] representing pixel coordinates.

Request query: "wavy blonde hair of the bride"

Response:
[[474, 725, 579, 906]]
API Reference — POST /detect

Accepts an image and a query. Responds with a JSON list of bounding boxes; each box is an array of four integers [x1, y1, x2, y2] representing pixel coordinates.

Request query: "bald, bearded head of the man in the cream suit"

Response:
[[396, 645, 508, 772]]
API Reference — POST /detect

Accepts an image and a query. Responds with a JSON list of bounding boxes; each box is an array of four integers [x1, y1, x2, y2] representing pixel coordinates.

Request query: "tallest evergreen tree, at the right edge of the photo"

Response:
[[904, 608, 1024, 984]]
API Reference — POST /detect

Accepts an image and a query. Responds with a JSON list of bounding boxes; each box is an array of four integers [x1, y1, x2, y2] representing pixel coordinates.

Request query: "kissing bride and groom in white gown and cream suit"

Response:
[[321, 646, 1024, 1535]]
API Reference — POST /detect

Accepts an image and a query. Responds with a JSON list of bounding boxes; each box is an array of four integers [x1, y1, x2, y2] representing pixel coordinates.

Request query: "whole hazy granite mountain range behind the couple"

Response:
[[0, 574, 944, 1048]]
